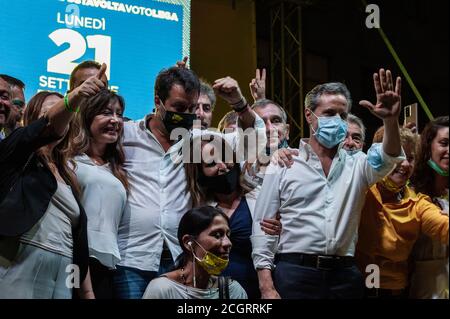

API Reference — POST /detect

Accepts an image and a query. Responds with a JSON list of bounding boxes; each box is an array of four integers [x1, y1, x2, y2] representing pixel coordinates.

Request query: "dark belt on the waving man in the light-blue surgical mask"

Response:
[[275, 253, 355, 270]]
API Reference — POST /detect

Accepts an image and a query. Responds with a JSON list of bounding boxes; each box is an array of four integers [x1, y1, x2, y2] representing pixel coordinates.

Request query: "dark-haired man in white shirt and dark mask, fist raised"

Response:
[[114, 67, 265, 299]]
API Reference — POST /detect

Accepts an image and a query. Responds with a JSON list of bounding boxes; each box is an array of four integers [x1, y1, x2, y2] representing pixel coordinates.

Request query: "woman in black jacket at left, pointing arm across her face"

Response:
[[0, 65, 106, 299]]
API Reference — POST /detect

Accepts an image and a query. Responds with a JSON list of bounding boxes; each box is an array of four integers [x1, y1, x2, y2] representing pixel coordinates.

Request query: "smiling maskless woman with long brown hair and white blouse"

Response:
[[69, 89, 129, 299]]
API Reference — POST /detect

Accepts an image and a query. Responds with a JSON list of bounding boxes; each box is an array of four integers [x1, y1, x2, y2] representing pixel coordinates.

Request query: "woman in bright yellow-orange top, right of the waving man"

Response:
[[356, 128, 449, 298]]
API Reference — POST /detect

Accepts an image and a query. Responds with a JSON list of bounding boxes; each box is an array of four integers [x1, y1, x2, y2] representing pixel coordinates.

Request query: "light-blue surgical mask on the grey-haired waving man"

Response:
[[311, 111, 347, 149]]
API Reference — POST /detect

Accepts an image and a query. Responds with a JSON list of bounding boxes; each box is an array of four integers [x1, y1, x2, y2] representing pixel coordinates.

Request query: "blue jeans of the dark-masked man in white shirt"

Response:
[[114, 252, 173, 299]]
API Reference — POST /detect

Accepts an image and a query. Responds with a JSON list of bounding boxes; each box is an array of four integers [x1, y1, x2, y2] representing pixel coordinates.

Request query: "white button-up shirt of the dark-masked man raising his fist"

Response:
[[118, 116, 266, 271]]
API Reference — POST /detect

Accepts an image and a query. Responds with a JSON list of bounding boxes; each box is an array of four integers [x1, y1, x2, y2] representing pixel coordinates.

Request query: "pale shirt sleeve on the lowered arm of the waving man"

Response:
[[250, 164, 281, 269]]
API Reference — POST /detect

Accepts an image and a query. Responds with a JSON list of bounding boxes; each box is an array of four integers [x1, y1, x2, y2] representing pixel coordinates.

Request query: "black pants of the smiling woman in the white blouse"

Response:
[[89, 258, 114, 299]]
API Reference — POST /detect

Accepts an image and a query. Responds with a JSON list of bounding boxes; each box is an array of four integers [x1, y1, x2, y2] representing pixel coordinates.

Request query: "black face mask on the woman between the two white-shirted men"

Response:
[[198, 164, 241, 195]]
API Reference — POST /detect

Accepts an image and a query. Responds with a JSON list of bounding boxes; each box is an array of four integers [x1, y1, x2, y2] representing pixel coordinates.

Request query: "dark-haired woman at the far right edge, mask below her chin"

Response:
[[410, 116, 449, 299]]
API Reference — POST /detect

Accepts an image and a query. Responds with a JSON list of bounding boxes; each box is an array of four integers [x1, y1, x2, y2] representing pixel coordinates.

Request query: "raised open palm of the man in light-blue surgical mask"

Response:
[[359, 69, 402, 120]]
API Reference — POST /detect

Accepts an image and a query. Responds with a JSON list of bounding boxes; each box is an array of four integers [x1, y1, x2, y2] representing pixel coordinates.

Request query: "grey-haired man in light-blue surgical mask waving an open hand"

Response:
[[252, 69, 402, 299]]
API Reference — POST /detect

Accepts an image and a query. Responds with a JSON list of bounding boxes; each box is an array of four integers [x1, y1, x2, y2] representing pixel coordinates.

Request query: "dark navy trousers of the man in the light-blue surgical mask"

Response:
[[273, 261, 364, 299]]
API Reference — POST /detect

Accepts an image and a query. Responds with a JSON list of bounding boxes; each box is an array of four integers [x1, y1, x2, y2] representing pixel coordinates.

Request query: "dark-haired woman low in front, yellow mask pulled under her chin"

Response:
[[143, 206, 247, 299]]
